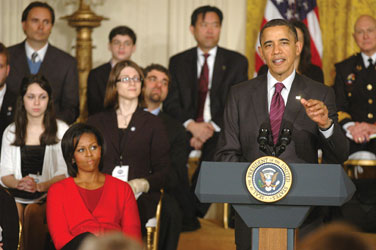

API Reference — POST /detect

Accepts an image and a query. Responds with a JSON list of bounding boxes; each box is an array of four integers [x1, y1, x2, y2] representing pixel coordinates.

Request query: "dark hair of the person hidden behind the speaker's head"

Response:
[[292, 20, 312, 75]]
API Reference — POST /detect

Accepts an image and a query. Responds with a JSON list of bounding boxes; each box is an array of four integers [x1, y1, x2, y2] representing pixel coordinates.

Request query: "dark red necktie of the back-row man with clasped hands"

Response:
[[196, 54, 210, 122]]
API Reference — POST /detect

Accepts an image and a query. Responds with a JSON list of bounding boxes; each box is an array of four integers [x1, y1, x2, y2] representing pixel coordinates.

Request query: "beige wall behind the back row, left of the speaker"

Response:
[[0, 0, 246, 67]]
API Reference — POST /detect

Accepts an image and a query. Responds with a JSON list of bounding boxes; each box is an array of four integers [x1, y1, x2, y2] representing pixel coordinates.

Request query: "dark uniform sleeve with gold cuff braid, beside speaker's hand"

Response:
[[333, 65, 352, 125]]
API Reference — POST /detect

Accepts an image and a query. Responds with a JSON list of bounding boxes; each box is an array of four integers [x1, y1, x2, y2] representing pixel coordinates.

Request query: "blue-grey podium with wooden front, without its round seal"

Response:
[[195, 162, 355, 250]]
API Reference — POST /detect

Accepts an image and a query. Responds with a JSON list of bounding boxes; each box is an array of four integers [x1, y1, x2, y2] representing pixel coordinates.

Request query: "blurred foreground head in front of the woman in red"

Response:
[[80, 233, 143, 250]]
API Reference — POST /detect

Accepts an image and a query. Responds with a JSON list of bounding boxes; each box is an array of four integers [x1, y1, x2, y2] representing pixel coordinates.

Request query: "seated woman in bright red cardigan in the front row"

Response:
[[47, 123, 141, 250]]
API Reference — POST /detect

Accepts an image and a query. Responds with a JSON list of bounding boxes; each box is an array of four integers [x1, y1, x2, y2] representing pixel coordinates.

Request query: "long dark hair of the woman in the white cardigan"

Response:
[[12, 74, 59, 146]]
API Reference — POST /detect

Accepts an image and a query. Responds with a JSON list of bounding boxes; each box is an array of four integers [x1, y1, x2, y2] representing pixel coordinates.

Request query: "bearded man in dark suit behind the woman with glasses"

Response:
[[142, 64, 200, 234]]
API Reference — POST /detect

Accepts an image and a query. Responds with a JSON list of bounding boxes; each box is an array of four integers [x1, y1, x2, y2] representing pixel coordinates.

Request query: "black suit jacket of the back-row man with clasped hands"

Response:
[[163, 47, 248, 130]]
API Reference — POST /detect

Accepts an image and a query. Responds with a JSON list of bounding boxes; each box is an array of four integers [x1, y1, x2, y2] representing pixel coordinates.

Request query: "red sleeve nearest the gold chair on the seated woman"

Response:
[[121, 183, 142, 241]]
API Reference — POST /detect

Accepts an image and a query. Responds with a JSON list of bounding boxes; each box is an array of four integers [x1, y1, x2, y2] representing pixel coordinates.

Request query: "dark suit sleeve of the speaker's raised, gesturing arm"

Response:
[[320, 88, 350, 163]]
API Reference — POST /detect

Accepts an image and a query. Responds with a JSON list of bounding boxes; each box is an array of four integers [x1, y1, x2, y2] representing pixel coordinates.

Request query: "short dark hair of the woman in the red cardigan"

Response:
[[61, 123, 104, 177]]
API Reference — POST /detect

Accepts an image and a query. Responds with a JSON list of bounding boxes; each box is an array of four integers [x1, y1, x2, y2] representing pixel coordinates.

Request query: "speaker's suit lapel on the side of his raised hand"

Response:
[[281, 73, 309, 125]]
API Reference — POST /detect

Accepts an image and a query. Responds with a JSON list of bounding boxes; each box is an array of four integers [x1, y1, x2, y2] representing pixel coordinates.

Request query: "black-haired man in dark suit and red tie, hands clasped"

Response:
[[163, 6, 248, 217]]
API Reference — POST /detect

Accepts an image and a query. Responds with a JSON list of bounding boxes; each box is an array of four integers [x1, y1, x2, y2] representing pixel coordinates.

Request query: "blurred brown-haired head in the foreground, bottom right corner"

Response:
[[297, 223, 376, 250]]
